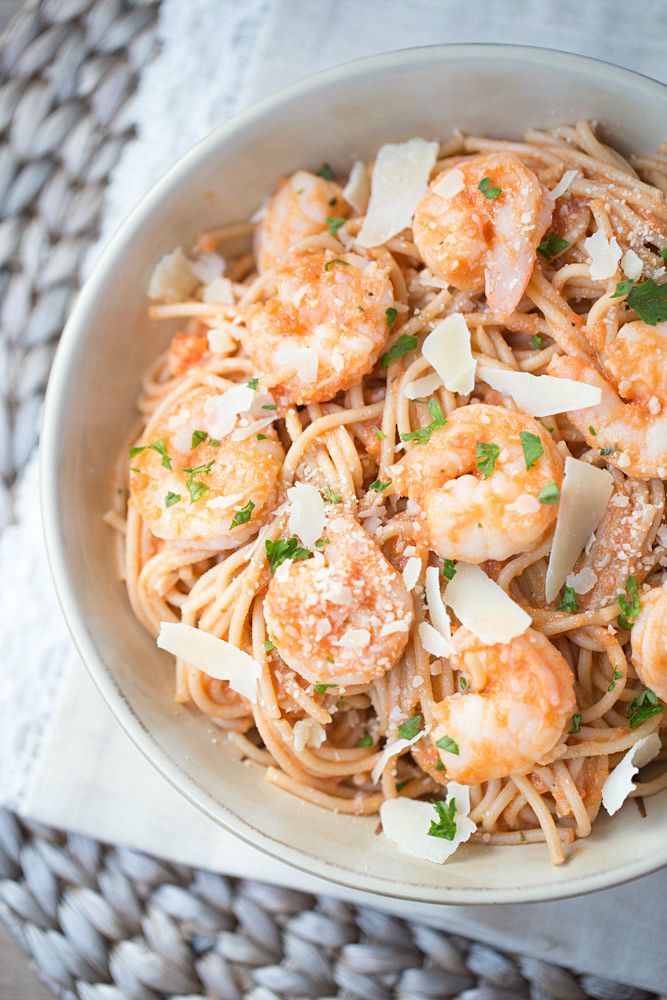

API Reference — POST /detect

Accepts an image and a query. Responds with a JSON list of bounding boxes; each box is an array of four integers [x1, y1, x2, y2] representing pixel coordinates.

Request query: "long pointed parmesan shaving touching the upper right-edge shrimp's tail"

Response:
[[477, 367, 602, 417]]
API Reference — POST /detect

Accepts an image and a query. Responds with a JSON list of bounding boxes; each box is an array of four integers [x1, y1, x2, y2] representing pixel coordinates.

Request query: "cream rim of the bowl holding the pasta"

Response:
[[39, 42, 667, 904]]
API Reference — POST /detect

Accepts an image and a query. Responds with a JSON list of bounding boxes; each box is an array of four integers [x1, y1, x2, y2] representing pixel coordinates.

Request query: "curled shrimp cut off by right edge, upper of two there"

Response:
[[547, 322, 667, 479]]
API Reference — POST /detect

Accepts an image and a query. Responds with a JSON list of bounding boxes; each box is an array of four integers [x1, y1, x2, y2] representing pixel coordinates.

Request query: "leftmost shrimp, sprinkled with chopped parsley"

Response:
[[130, 386, 285, 547]]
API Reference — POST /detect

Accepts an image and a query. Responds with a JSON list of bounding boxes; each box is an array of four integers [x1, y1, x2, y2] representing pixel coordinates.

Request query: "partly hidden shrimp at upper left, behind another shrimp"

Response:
[[256, 170, 350, 272]]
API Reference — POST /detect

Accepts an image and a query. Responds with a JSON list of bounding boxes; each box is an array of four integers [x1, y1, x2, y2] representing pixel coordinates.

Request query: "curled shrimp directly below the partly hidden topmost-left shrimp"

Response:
[[240, 250, 394, 404]]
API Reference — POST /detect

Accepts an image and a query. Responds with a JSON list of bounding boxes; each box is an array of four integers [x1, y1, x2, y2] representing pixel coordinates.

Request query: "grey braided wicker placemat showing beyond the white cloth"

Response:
[[0, 0, 656, 1000]]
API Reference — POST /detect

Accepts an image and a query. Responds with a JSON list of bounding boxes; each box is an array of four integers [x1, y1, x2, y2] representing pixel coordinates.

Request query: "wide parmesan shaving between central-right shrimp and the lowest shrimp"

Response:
[[445, 563, 532, 646]]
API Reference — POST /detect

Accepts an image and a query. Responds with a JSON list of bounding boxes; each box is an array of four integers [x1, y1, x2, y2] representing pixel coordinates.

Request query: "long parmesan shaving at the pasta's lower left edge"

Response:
[[157, 622, 261, 703]]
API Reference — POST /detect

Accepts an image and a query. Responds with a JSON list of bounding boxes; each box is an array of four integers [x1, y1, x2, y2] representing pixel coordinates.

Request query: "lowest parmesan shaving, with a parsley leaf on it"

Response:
[[380, 781, 477, 865]]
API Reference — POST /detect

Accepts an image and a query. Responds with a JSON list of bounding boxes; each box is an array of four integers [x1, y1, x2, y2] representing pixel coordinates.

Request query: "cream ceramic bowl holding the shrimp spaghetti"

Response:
[[42, 45, 667, 903]]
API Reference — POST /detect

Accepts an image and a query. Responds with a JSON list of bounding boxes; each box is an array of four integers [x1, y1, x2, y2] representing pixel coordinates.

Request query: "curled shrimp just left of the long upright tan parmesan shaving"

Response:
[[390, 403, 563, 563]]
